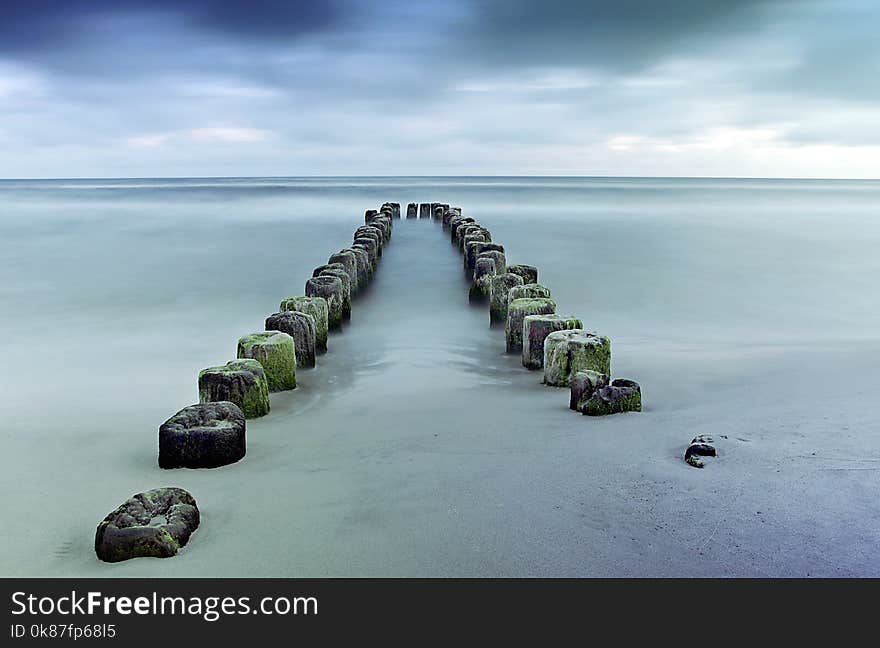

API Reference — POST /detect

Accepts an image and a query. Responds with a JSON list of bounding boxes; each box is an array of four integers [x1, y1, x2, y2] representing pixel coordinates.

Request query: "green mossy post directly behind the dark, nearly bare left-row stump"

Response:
[[199, 359, 269, 418]]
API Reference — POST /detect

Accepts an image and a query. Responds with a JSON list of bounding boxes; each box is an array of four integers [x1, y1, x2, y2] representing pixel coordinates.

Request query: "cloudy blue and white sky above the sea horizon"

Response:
[[0, 0, 880, 178]]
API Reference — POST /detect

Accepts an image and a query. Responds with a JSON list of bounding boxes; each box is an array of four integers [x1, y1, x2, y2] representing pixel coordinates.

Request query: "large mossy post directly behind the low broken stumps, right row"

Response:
[[544, 329, 611, 387]]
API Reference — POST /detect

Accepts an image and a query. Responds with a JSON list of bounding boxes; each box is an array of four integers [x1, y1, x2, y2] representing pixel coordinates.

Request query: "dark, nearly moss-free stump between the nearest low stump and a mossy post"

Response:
[[159, 401, 245, 468]]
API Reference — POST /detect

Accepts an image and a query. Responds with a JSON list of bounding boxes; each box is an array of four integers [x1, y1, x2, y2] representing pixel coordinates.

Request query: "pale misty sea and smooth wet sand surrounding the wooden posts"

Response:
[[0, 177, 880, 576]]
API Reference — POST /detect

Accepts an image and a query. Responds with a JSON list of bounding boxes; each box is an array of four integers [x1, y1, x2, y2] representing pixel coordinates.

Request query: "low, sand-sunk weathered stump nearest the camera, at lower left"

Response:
[[95, 488, 199, 562]]
